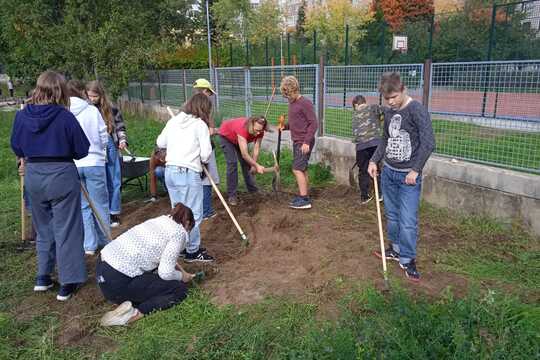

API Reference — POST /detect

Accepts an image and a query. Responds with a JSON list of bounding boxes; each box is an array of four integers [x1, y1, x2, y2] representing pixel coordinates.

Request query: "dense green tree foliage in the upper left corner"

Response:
[[0, 0, 198, 94]]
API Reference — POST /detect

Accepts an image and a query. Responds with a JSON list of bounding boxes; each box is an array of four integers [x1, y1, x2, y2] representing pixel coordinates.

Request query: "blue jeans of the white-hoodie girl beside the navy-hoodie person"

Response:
[[77, 166, 111, 251]]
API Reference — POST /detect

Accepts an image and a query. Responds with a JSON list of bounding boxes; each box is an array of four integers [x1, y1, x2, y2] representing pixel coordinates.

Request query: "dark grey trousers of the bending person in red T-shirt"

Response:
[[219, 136, 258, 197]]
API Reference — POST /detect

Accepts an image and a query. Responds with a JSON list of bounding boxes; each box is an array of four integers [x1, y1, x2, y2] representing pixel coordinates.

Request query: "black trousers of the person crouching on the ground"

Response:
[[96, 258, 187, 314]]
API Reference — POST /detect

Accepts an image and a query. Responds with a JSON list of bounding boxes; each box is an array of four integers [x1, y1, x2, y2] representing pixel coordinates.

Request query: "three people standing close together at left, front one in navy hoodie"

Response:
[[11, 71, 127, 301]]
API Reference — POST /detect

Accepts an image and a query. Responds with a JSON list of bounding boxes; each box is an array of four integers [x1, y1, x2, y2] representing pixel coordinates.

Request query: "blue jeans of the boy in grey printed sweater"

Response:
[[381, 166, 422, 264]]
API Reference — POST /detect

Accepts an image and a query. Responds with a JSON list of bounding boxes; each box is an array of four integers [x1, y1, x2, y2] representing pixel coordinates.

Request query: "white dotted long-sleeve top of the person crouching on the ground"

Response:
[[101, 215, 188, 280]]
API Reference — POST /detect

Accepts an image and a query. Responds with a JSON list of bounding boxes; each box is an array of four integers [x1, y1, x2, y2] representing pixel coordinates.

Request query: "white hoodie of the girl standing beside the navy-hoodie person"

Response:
[[69, 97, 109, 167]]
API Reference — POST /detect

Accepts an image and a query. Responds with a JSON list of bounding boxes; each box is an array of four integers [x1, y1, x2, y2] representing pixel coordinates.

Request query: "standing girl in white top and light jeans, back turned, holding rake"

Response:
[[156, 94, 214, 262]]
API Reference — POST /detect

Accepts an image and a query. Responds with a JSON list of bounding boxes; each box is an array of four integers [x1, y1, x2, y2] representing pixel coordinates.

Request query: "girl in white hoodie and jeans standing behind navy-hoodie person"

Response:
[[67, 80, 110, 255]]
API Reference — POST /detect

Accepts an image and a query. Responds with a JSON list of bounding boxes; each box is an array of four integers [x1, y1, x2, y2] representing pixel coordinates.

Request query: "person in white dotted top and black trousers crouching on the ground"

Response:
[[96, 203, 195, 326]]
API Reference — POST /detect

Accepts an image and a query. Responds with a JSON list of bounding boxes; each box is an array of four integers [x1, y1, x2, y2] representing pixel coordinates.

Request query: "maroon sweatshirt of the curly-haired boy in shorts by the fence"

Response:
[[287, 96, 319, 145]]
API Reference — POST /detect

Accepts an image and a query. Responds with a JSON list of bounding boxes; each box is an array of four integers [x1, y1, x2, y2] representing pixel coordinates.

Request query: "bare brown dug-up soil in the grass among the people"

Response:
[[14, 187, 467, 349]]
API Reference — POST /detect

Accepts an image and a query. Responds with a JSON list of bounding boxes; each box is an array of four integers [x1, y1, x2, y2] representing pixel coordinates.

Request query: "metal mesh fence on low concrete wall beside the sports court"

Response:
[[128, 60, 540, 173]]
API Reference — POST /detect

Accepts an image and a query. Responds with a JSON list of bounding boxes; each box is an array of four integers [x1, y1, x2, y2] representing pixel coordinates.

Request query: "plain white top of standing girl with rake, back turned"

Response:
[[156, 112, 212, 172]]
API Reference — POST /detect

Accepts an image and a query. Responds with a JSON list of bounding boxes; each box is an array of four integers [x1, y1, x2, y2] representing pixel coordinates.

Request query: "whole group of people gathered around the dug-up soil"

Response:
[[11, 71, 435, 325]]
